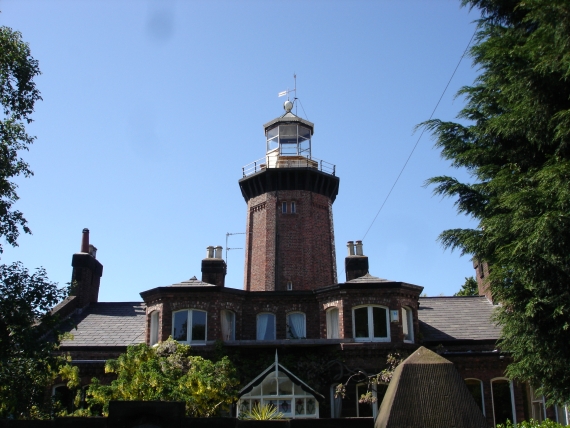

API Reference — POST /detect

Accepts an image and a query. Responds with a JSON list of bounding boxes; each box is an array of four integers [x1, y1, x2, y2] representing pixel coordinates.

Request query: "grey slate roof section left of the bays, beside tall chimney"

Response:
[[61, 302, 146, 348]]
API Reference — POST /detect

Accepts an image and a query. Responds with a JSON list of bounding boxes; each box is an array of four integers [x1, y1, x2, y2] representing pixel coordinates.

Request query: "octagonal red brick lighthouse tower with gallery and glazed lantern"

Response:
[[239, 101, 339, 291]]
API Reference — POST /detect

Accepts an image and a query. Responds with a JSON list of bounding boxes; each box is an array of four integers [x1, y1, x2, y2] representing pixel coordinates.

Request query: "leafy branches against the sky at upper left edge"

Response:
[[0, 27, 41, 253]]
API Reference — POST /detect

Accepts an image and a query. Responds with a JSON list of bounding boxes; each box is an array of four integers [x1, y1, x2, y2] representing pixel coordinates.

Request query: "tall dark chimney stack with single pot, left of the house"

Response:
[[70, 228, 103, 309]]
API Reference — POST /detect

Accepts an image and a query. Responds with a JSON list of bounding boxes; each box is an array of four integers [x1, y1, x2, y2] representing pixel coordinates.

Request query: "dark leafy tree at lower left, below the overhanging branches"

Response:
[[0, 263, 66, 418]]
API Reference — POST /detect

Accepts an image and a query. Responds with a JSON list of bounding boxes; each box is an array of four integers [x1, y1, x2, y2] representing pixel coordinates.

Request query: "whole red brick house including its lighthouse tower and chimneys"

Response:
[[55, 101, 567, 426]]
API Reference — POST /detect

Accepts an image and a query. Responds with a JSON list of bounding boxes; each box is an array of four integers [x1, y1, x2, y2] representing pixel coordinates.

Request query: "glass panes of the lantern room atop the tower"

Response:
[[265, 123, 311, 159]]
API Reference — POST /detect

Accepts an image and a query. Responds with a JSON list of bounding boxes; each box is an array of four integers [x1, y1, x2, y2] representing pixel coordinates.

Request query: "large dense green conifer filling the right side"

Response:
[[423, 0, 570, 403]]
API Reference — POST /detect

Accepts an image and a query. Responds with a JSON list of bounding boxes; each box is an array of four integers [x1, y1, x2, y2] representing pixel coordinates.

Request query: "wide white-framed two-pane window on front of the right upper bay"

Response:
[[352, 305, 390, 342]]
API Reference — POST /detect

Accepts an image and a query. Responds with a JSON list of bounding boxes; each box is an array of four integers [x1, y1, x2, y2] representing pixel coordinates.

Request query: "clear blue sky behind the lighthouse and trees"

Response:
[[0, 0, 478, 301]]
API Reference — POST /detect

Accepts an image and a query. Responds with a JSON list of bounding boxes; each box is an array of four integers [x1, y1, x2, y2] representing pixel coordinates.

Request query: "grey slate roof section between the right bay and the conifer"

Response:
[[418, 296, 501, 342]]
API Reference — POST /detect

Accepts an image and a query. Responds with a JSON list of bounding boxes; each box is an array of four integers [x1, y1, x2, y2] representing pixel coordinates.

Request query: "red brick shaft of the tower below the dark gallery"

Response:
[[244, 190, 337, 291]]
